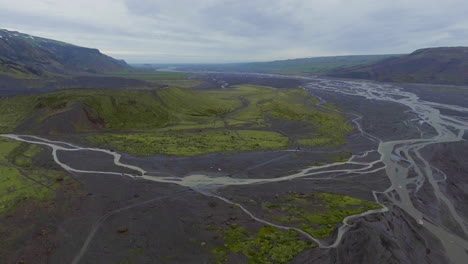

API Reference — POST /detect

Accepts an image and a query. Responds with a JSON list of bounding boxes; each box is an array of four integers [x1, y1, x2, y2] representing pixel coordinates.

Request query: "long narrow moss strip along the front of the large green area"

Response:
[[88, 130, 288, 156]]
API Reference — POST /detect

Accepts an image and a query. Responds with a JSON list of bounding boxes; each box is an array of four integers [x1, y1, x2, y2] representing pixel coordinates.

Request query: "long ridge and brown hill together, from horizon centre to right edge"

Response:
[[163, 47, 468, 85]]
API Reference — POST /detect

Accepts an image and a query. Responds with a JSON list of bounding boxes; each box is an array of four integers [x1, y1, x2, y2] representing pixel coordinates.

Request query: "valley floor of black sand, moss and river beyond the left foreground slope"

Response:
[[2, 69, 468, 263]]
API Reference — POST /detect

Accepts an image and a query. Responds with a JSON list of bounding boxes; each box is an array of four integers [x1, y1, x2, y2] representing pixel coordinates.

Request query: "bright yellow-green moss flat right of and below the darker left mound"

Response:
[[82, 85, 351, 156]]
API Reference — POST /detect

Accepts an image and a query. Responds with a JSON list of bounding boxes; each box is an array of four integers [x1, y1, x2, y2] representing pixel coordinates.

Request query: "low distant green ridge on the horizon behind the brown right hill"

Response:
[[162, 55, 400, 75]]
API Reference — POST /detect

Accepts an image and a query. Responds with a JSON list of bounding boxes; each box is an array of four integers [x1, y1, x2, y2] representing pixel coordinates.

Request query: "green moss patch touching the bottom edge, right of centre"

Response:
[[212, 225, 312, 264]]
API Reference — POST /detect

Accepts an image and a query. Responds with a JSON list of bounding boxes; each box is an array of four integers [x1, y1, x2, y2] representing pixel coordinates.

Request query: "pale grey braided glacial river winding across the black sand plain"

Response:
[[2, 76, 468, 264]]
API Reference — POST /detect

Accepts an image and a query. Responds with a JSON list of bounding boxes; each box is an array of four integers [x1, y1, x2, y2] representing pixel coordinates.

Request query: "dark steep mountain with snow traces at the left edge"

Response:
[[0, 29, 130, 77]]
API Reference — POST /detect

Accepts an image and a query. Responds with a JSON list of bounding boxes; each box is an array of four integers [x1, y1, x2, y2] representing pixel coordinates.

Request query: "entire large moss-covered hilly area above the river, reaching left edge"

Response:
[[0, 85, 351, 155]]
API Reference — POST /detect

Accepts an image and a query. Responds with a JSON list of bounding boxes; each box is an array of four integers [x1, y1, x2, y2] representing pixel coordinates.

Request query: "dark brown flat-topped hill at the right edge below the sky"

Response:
[[327, 47, 468, 85]]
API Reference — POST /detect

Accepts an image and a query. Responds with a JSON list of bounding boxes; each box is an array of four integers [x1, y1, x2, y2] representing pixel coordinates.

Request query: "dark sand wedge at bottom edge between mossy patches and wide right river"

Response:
[[291, 207, 449, 264]]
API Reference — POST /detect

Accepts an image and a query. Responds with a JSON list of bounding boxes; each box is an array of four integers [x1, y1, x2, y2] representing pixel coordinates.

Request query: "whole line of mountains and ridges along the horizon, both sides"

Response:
[[0, 29, 468, 86]]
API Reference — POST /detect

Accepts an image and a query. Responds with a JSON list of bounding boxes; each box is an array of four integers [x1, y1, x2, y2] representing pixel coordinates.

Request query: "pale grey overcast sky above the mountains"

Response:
[[0, 0, 468, 63]]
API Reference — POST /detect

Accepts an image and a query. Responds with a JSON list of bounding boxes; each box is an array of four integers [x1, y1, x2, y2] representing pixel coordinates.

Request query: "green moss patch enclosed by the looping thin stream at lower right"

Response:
[[262, 193, 381, 239]]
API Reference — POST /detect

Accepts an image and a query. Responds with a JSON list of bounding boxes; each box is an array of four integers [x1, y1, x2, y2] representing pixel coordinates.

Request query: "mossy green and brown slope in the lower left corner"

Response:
[[0, 137, 82, 263]]
